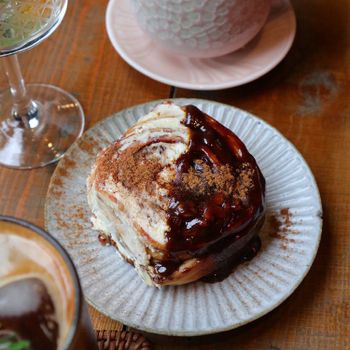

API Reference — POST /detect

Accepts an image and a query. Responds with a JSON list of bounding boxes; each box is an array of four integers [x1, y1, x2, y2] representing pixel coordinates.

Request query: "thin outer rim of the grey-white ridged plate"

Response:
[[44, 97, 323, 337]]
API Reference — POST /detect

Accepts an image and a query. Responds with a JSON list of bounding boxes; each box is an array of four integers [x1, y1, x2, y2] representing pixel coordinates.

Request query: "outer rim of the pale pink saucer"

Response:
[[105, 0, 297, 91]]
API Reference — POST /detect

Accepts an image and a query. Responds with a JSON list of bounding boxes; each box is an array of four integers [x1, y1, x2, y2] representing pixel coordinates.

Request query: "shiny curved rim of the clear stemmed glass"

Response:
[[0, 0, 68, 57]]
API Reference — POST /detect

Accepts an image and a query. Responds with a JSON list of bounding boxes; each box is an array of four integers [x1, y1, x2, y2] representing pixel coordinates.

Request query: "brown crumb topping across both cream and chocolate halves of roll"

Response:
[[97, 141, 255, 201]]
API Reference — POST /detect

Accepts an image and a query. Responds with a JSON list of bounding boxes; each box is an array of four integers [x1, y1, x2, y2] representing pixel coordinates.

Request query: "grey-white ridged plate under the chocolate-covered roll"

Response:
[[45, 99, 322, 336]]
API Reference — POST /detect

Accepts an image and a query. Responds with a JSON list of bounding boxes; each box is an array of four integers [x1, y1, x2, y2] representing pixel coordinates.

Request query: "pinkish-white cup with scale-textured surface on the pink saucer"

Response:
[[132, 0, 271, 58]]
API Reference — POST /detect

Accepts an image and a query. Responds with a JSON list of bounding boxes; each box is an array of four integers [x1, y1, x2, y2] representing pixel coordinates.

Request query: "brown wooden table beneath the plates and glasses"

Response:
[[0, 0, 350, 350]]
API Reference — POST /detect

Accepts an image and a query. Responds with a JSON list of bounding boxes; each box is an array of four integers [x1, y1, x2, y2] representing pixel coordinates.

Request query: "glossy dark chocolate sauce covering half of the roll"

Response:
[[154, 105, 265, 282]]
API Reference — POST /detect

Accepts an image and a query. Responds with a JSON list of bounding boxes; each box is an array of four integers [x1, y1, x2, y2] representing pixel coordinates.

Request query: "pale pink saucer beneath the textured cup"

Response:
[[106, 0, 296, 90]]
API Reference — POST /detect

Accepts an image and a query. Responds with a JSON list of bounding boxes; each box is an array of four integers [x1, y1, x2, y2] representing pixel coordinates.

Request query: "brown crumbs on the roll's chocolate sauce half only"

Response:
[[181, 160, 254, 200]]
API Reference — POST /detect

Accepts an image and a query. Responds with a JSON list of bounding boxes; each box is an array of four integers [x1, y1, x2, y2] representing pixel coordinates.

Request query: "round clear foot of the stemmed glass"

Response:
[[0, 84, 84, 169]]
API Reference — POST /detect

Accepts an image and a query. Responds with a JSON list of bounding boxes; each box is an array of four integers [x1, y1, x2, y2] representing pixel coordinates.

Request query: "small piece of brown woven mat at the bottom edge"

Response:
[[96, 331, 152, 350]]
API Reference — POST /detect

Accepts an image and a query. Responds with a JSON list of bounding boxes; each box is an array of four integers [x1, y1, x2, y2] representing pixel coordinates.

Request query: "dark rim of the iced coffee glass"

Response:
[[0, 215, 83, 349]]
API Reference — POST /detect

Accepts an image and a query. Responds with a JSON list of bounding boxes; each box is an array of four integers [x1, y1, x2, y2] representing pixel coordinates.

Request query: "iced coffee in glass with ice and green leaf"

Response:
[[0, 216, 97, 350]]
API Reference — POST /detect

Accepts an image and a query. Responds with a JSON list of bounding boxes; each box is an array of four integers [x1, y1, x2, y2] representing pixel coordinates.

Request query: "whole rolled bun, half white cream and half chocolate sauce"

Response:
[[87, 102, 265, 286]]
